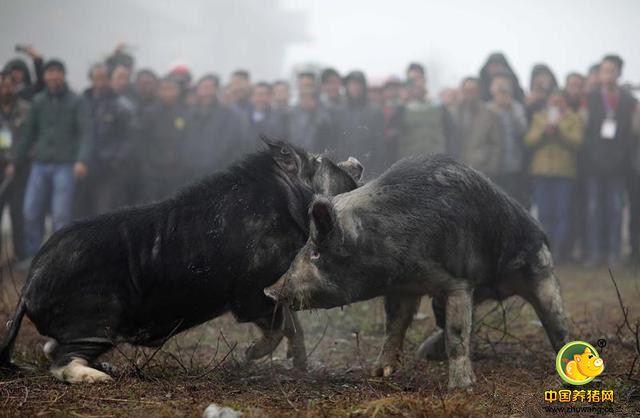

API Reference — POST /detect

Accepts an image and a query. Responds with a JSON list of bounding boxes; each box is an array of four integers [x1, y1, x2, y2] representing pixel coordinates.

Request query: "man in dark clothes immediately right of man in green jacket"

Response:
[[77, 64, 133, 216]]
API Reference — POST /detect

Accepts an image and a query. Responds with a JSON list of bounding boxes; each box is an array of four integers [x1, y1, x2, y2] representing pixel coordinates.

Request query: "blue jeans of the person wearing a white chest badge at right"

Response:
[[587, 177, 624, 262]]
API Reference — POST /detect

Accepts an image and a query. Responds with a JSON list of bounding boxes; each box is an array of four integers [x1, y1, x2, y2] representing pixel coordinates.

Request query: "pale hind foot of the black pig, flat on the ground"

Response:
[[45, 341, 112, 383]]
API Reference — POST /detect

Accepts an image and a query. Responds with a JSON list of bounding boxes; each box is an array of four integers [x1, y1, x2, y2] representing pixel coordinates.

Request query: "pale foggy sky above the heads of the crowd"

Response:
[[0, 0, 640, 91]]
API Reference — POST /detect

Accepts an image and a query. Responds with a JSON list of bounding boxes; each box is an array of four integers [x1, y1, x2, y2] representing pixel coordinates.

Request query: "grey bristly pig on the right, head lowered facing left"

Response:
[[265, 156, 569, 388]]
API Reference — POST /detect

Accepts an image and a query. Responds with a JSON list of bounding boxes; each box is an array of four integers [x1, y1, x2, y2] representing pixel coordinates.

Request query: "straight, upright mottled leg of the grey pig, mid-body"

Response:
[[444, 288, 476, 389]]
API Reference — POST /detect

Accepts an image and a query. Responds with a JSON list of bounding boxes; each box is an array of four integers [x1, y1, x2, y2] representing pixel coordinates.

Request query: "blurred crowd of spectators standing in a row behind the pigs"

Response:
[[0, 47, 640, 266]]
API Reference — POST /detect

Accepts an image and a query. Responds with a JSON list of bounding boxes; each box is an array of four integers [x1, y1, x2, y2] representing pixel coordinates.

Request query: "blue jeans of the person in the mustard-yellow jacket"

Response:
[[533, 176, 573, 260]]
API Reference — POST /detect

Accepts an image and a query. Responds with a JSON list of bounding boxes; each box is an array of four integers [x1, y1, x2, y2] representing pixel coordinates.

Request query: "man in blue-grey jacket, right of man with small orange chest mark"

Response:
[[182, 75, 247, 181]]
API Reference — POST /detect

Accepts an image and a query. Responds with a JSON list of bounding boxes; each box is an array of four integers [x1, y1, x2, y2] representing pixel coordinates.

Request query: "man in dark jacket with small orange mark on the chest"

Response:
[[137, 77, 188, 202]]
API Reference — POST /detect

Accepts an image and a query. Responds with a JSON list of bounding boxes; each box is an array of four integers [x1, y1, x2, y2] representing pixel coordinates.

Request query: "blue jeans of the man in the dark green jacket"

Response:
[[24, 162, 76, 257]]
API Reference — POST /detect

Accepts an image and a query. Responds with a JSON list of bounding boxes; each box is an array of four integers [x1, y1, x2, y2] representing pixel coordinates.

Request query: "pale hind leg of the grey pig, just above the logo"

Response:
[[518, 272, 570, 352]]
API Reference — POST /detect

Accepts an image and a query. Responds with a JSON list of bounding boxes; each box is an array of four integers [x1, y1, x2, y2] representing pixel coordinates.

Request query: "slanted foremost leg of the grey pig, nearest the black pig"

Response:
[[372, 295, 420, 377]]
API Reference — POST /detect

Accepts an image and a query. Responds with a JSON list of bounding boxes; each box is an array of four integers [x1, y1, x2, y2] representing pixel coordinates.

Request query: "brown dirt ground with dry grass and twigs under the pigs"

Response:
[[0, 267, 640, 417]]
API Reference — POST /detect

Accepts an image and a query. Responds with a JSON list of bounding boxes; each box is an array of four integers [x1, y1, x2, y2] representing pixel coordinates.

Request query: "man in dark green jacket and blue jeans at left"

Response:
[[11, 60, 92, 257]]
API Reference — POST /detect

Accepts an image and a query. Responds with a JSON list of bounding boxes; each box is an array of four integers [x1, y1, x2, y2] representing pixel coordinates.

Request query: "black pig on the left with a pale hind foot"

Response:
[[0, 138, 362, 383]]
